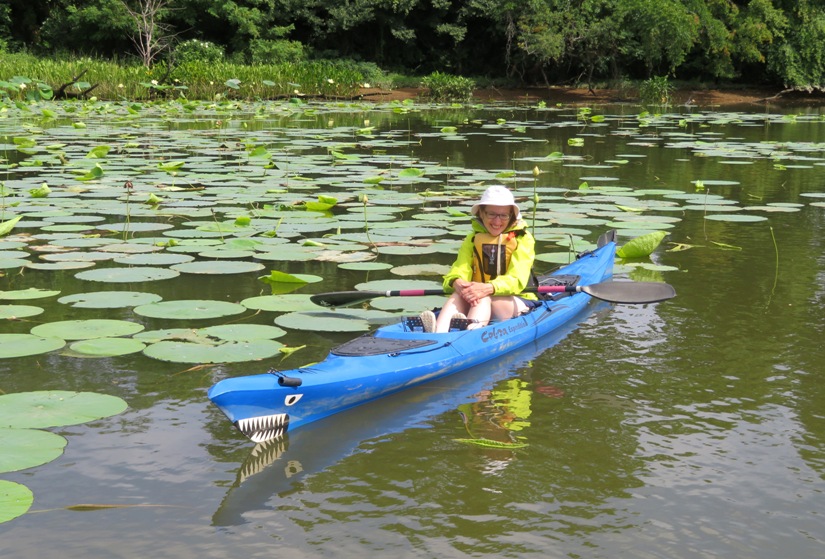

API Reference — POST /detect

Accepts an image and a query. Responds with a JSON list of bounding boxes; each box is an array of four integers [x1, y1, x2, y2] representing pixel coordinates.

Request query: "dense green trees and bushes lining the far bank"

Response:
[[0, 0, 825, 92]]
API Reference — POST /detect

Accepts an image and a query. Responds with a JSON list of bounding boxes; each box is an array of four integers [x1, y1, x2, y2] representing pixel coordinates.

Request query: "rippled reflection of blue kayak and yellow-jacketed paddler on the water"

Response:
[[212, 300, 611, 526]]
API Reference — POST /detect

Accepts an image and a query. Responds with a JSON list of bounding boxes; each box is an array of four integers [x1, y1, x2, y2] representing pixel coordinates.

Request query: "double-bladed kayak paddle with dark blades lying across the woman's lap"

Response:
[[309, 281, 676, 307]]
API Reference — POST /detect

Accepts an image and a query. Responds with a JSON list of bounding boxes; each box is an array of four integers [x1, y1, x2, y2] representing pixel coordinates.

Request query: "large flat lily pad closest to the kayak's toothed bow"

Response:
[[143, 340, 284, 363]]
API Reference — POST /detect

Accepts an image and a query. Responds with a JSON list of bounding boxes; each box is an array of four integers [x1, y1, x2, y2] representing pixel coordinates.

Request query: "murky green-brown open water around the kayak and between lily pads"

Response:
[[0, 98, 825, 559]]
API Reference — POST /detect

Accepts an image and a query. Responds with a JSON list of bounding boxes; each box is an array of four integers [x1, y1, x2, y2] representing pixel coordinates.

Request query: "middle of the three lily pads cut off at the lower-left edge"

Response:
[[0, 428, 68, 473]]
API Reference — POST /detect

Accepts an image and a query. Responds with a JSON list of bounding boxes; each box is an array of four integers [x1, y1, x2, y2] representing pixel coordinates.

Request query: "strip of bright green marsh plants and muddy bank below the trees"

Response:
[[0, 54, 825, 110]]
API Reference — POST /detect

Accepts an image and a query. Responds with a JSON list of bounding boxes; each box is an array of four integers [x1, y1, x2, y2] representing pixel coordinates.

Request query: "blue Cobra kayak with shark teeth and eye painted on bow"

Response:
[[208, 232, 616, 442]]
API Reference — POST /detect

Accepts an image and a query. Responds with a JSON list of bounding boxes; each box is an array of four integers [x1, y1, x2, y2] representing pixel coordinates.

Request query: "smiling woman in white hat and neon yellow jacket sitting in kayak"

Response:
[[421, 185, 538, 332]]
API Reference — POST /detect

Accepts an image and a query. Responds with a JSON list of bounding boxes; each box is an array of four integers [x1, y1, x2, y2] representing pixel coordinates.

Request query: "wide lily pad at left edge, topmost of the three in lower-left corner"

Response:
[[0, 390, 128, 429]]
